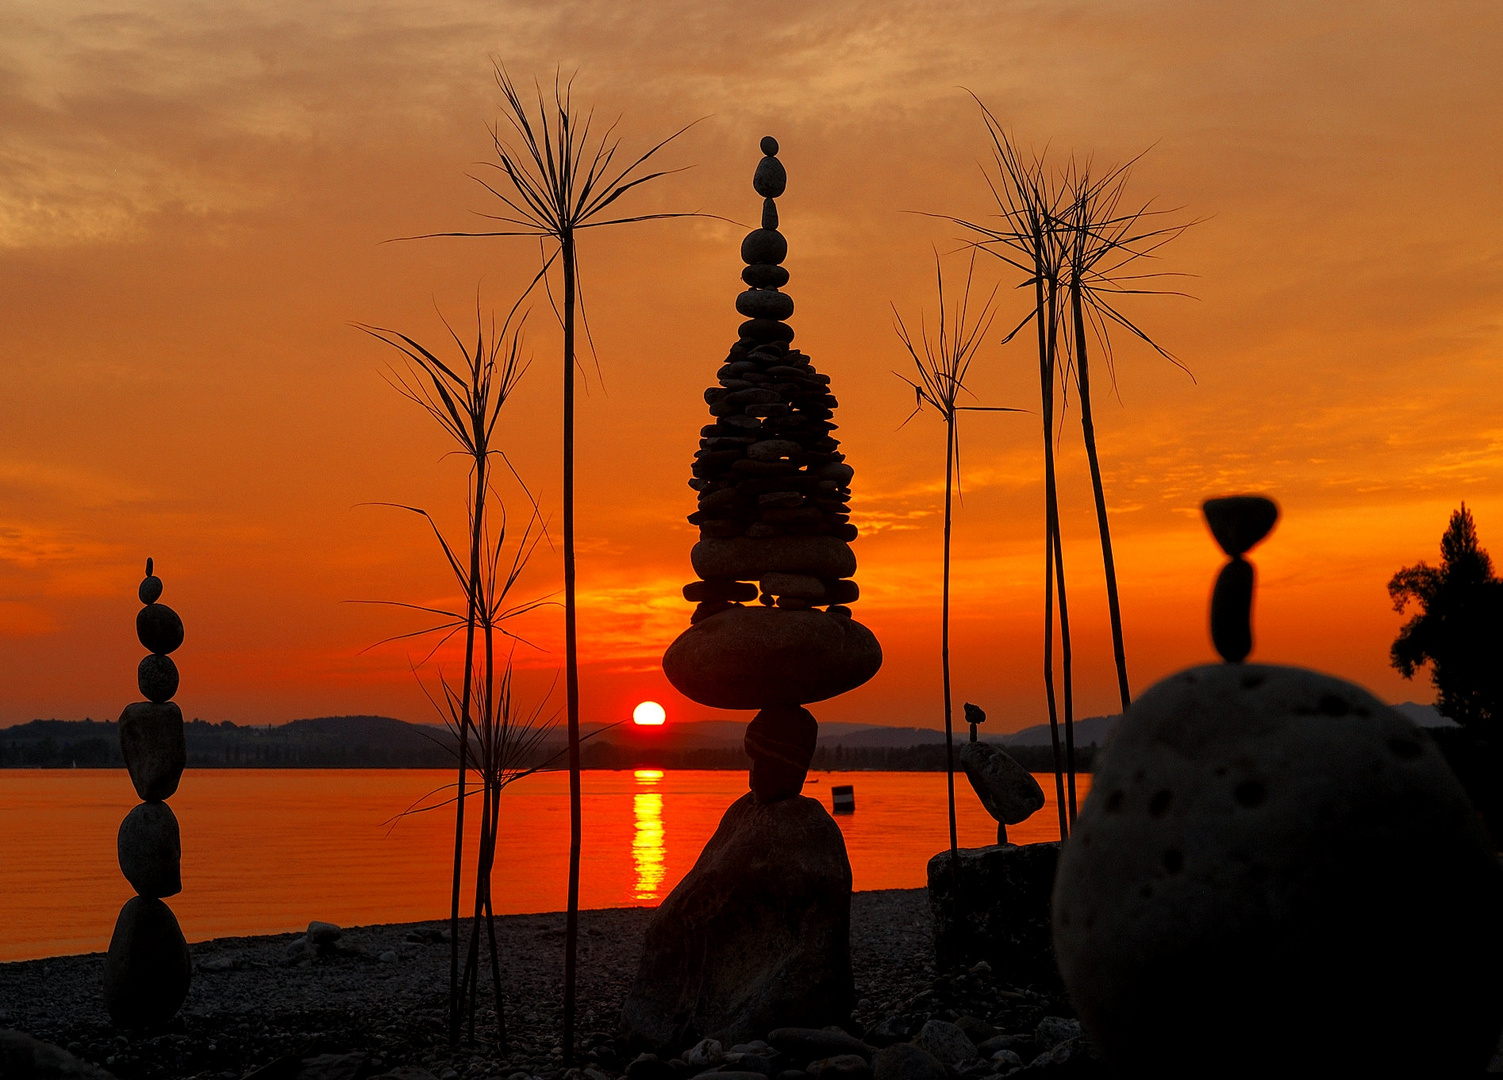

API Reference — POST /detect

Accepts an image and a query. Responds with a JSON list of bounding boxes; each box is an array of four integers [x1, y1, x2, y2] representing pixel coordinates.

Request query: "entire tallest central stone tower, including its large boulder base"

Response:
[[621, 138, 882, 1050]]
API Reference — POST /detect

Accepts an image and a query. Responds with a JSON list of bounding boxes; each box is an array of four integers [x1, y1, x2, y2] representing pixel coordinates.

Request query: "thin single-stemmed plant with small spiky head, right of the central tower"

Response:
[[893, 252, 1019, 901]]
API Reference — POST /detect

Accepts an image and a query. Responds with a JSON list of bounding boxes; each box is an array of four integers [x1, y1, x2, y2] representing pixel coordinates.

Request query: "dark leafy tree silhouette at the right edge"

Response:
[[1389, 503, 1503, 736]]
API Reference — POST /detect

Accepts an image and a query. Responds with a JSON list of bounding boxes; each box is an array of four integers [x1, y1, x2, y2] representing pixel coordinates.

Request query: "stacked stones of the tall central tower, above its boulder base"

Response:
[[663, 137, 882, 802]]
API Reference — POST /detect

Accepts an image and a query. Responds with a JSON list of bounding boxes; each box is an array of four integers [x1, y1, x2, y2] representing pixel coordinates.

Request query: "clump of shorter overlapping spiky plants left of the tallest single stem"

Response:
[[361, 300, 544, 1044]]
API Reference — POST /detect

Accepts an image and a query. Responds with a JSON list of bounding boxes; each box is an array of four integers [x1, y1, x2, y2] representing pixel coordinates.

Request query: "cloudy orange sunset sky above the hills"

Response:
[[0, 0, 1503, 729]]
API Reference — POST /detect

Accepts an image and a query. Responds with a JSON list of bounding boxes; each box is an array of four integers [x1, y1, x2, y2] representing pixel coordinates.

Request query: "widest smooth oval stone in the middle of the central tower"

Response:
[[663, 606, 882, 709]]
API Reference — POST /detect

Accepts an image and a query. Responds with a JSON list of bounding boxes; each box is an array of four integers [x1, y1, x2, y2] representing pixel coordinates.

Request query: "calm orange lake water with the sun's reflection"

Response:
[[0, 769, 1091, 961]]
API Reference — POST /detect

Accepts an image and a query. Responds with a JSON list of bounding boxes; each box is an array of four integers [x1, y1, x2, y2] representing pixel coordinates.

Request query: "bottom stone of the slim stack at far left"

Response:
[[104, 897, 192, 1027]]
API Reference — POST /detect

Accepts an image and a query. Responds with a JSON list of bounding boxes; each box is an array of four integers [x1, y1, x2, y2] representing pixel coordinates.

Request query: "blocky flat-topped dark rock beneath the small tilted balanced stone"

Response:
[[929, 843, 1060, 984]]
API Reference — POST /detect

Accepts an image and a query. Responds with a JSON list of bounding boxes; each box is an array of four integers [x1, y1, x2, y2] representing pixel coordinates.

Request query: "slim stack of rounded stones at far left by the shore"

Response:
[[104, 559, 192, 1027]]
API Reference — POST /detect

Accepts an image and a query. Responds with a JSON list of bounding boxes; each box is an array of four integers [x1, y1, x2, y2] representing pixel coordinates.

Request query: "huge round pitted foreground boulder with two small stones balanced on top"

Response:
[[1054, 497, 1503, 1077]]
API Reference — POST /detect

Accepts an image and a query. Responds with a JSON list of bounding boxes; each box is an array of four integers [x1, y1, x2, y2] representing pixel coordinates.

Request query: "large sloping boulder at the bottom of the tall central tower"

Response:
[[621, 795, 855, 1051]]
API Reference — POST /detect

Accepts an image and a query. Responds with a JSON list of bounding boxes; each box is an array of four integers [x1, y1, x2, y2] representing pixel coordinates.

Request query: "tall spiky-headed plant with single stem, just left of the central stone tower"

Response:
[[412, 66, 696, 1065]]
